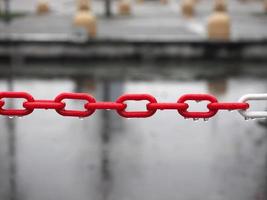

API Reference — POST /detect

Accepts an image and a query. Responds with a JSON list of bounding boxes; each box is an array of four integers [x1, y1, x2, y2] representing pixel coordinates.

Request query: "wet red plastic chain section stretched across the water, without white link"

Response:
[[0, 92, 249, 118]]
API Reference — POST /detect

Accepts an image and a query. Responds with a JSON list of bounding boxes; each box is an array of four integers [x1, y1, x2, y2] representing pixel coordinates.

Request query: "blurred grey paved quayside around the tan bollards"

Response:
[[0, 0, 267, 41]]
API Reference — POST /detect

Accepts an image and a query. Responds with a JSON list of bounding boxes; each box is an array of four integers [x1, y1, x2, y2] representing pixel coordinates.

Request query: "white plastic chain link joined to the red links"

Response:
[[238, 93, 267, 119]]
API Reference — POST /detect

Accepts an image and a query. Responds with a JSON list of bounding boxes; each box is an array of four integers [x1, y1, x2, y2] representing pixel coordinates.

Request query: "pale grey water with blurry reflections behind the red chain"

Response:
[[0, 77, 267, 200]]
